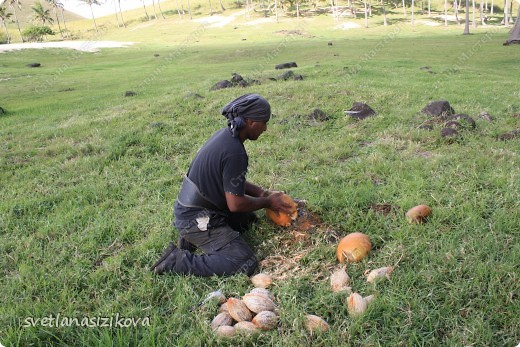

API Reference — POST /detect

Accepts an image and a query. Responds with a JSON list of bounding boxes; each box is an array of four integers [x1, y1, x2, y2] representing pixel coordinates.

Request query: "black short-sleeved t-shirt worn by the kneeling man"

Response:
[[174, 128, 248, 228]]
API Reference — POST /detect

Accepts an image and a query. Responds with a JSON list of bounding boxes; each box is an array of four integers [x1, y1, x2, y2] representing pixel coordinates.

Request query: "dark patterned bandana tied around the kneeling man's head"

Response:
[[222, 94, 271, 137]]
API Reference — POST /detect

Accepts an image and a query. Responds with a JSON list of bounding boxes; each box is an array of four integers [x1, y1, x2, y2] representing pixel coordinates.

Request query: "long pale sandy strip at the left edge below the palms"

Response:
[[0, 41, 134, 52]]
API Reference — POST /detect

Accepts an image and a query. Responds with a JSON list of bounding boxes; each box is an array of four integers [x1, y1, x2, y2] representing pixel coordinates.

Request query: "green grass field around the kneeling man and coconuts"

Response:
[[0, 4, 520, 347]]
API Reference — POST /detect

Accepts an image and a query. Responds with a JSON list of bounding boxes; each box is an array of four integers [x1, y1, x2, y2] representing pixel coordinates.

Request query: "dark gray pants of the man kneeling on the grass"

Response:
[[172, 213, 258, 276]]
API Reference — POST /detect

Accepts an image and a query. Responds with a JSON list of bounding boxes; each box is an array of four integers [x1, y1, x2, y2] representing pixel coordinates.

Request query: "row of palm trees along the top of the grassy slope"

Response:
[[0, 0, 520, 43]]
